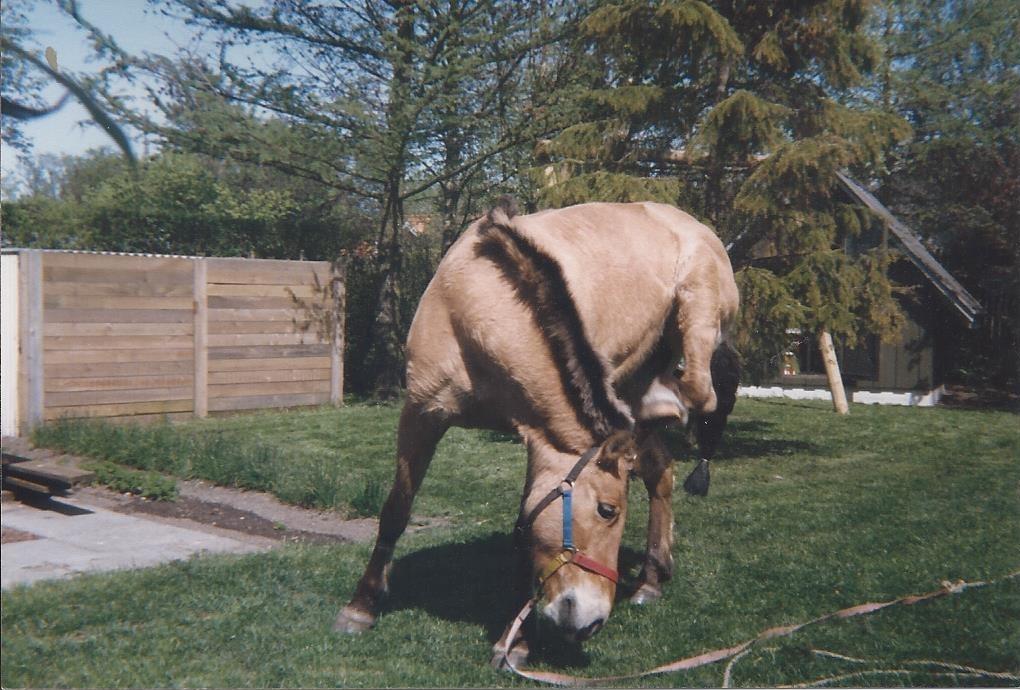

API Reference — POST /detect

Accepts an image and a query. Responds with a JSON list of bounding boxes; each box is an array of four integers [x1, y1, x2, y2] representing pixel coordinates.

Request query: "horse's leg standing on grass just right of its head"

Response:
[[630, 430, 673, 604]]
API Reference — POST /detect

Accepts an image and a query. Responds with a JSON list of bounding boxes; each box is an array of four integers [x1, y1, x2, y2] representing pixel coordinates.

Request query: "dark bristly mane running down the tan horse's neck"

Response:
[[479, 197, 633, 442]]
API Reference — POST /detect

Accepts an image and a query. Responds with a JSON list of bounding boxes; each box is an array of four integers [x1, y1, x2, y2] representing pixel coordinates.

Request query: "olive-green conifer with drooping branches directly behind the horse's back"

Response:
[[537, 0, 909, 387]]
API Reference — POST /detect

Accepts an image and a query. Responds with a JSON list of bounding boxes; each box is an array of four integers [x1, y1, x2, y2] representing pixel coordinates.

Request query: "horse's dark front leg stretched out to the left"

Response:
[[334, 401, 449, 633]]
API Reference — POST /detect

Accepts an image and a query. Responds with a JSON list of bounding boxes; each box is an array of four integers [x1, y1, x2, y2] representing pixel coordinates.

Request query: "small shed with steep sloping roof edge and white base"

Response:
[[740, 174, 984, 406]]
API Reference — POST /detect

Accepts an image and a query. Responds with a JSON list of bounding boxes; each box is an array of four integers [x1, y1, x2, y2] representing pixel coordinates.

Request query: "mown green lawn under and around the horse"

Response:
[[2, 399, 1020, 687]]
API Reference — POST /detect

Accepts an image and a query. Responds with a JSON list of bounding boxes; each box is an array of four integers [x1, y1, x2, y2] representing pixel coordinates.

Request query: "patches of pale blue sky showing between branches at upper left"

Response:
[[2, 0, 202, 188]]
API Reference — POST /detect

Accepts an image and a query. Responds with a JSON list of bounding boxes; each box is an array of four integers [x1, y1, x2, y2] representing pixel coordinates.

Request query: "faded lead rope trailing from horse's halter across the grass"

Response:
[[505, 570, 1020, 687]]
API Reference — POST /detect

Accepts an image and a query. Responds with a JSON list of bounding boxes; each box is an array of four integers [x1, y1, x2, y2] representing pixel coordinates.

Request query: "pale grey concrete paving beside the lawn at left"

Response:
[[0, 497, 266, 589]]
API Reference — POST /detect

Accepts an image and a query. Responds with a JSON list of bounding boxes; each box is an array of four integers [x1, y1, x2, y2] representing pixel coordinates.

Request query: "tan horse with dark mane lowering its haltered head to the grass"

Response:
[[336, 200, 738, 663]]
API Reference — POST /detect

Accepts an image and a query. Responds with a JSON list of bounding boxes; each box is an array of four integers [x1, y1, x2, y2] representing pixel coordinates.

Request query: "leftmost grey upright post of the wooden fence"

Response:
[[17, 249, 44, 436]]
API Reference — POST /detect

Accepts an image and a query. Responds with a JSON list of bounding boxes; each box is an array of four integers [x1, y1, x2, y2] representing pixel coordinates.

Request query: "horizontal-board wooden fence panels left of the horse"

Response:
[[3, 250, 344, 434]]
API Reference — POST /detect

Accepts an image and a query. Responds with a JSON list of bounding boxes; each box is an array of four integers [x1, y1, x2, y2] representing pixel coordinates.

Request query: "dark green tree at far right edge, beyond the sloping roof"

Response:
[[876, 0, 1020, 389]]
